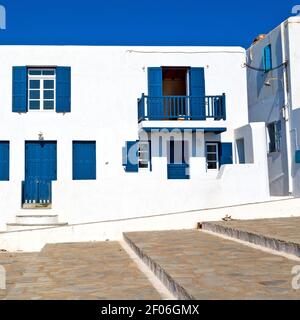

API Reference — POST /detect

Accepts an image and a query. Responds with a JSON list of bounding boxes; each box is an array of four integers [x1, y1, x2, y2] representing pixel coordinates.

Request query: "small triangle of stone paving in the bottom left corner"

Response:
[[0, 252, 37, 300]]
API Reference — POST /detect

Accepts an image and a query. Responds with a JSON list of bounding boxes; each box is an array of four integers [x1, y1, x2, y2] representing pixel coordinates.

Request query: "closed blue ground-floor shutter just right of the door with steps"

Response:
[[73, 141, 96, 180]]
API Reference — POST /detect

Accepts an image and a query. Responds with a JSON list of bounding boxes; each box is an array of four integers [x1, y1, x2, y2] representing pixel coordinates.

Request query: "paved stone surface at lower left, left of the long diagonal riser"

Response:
[[2, 242, 161, 300]]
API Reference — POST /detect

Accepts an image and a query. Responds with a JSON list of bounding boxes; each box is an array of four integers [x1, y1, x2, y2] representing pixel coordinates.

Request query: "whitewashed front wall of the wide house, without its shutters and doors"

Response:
[[0, 46, 268, 230]]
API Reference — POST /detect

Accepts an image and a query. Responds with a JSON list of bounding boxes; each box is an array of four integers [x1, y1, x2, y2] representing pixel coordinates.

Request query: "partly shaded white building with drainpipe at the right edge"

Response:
[[247, 17, 300, 196]]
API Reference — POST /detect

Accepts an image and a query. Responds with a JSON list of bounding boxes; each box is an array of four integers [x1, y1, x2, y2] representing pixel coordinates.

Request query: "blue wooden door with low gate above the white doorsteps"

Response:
[[23, 141, 57, 203]]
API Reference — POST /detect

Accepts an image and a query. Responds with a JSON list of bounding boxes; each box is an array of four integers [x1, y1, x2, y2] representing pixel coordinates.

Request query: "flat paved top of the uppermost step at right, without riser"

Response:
[[205, 217, 300, 244]]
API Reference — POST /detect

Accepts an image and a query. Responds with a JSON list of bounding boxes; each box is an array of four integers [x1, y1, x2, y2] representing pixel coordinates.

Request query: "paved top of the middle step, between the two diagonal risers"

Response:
[[126, 230, 300, 299]]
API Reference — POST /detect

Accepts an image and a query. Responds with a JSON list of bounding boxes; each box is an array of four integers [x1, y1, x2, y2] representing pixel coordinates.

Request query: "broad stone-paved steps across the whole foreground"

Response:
[[0, 216, 300, 300]]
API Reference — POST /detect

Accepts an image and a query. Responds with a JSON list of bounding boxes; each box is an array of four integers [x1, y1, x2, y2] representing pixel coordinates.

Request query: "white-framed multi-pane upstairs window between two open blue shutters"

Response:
[[28, 68, 56, 111]]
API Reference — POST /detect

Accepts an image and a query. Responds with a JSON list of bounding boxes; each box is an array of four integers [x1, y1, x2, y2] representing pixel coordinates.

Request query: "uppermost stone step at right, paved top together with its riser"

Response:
[[199, 217, 300, 257]]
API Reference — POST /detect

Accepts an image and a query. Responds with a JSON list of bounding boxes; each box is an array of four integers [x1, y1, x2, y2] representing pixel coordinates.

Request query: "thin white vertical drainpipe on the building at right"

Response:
[[281, 23, 293, 195]]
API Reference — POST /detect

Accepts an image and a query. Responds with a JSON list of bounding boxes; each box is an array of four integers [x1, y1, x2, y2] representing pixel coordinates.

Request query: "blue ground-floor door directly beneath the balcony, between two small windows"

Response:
[[168, 140, 190, 179]]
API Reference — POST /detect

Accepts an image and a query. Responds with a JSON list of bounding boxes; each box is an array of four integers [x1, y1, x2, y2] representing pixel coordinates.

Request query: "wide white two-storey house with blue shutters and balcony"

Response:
[[0, 45, 270, 230]]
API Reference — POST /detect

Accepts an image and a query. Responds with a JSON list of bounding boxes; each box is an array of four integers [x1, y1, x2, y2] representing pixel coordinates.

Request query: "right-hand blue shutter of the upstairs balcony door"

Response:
[[190, 68, 206, 120]]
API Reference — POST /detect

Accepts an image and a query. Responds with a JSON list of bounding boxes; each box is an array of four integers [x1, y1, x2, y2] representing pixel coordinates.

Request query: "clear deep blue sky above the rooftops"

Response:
[[0, 0, 300, 47]]
